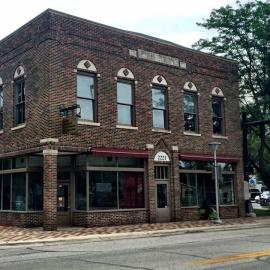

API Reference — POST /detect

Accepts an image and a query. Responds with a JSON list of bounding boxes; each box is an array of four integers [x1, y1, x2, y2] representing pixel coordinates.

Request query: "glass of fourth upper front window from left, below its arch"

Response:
[[184, 93, 198, 132]]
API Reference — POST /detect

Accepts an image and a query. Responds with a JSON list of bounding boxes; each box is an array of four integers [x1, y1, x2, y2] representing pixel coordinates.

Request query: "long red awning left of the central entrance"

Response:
[[91, 147, 148, 158]]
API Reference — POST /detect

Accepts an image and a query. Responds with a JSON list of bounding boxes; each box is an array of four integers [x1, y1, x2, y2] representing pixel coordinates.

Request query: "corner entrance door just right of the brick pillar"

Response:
[[57, 182, 71, 226]]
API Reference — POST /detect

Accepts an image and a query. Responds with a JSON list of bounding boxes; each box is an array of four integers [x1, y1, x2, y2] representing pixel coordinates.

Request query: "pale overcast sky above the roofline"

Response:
[[0, 0, 247, 47]]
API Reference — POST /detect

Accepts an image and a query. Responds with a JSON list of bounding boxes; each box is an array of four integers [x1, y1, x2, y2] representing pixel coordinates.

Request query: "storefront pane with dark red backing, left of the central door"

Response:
[[118, 172, 144, 208]]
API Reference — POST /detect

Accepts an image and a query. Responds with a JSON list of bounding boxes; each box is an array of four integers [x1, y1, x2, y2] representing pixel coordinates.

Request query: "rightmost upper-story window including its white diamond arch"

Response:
[[212, 87, 225, 135]]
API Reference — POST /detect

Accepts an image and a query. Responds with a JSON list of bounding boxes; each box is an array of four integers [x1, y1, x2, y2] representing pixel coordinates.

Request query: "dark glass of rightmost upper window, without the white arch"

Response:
[[212, 97, 224, 134]]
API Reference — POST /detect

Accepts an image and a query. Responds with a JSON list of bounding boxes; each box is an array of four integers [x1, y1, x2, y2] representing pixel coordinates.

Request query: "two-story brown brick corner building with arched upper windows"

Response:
[[0, 10, 244, 230]]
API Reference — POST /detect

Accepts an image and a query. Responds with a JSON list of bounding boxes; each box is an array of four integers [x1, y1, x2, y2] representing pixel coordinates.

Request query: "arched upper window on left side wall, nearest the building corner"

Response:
[[14, 66, 25, 125]]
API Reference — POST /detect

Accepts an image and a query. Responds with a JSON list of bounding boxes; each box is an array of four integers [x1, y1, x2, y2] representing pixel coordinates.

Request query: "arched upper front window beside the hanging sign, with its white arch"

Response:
[[77, 60, 97, 122]]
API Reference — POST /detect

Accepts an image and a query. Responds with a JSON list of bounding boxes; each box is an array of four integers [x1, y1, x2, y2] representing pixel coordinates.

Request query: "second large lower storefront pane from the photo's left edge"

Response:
[[12, 173, 26, 211]]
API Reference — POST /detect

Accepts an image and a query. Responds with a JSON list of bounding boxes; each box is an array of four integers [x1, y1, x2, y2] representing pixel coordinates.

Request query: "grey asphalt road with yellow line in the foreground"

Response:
[[0, 228, 270, 270]]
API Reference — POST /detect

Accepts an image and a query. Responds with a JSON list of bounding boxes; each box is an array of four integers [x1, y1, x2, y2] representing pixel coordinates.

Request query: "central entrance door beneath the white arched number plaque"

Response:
[[156, 181, 170, 222]]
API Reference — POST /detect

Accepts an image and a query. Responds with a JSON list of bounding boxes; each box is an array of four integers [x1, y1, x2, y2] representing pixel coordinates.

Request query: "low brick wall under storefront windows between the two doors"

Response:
[[72, 210, 148, 227]]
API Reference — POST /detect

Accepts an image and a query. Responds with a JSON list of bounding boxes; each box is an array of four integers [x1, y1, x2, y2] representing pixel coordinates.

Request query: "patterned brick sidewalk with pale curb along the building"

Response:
[[0, 217, 270, 246]]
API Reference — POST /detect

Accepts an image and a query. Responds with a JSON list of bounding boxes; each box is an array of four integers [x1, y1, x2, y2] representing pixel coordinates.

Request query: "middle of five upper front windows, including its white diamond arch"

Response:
[[152, 75, 168, 129]]
